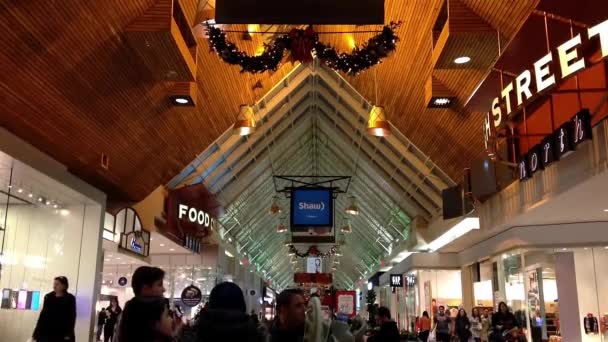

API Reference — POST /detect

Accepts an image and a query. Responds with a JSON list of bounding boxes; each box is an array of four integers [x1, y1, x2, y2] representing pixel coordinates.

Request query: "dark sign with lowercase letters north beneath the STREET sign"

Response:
[[518, 109, 592, 181]]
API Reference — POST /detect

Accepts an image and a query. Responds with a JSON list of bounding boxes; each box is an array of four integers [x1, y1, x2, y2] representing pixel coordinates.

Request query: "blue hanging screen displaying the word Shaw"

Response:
[[291, 188, 333, 227]]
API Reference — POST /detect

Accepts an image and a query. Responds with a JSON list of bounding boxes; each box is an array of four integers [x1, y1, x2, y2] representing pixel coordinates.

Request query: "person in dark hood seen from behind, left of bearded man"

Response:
[[177, 282, 266, 342]]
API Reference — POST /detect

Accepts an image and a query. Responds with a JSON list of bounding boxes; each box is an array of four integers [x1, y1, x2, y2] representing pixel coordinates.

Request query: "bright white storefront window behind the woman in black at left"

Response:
[[0, 152, 102, 341]]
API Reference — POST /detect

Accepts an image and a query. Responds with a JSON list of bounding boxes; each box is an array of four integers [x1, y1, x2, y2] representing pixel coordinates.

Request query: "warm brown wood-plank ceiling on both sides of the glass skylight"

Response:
[[0, 0, 538, 201]]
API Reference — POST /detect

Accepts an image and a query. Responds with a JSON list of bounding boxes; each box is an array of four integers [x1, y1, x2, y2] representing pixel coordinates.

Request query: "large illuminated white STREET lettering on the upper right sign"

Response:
[[483, 20, 608, 148]]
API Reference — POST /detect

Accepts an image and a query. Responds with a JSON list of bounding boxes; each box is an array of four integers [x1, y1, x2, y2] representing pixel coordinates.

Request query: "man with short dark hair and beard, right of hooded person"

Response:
[[270, 289, 306, 342]]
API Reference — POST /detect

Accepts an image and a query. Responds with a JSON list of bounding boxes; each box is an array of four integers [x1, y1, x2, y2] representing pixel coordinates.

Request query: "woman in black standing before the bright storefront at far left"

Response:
[[32, 276, 76, 342]]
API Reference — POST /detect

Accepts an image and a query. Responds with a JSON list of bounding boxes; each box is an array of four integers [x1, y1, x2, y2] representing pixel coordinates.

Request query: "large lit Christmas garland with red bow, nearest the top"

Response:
[[206, 22, 401, 75]]
